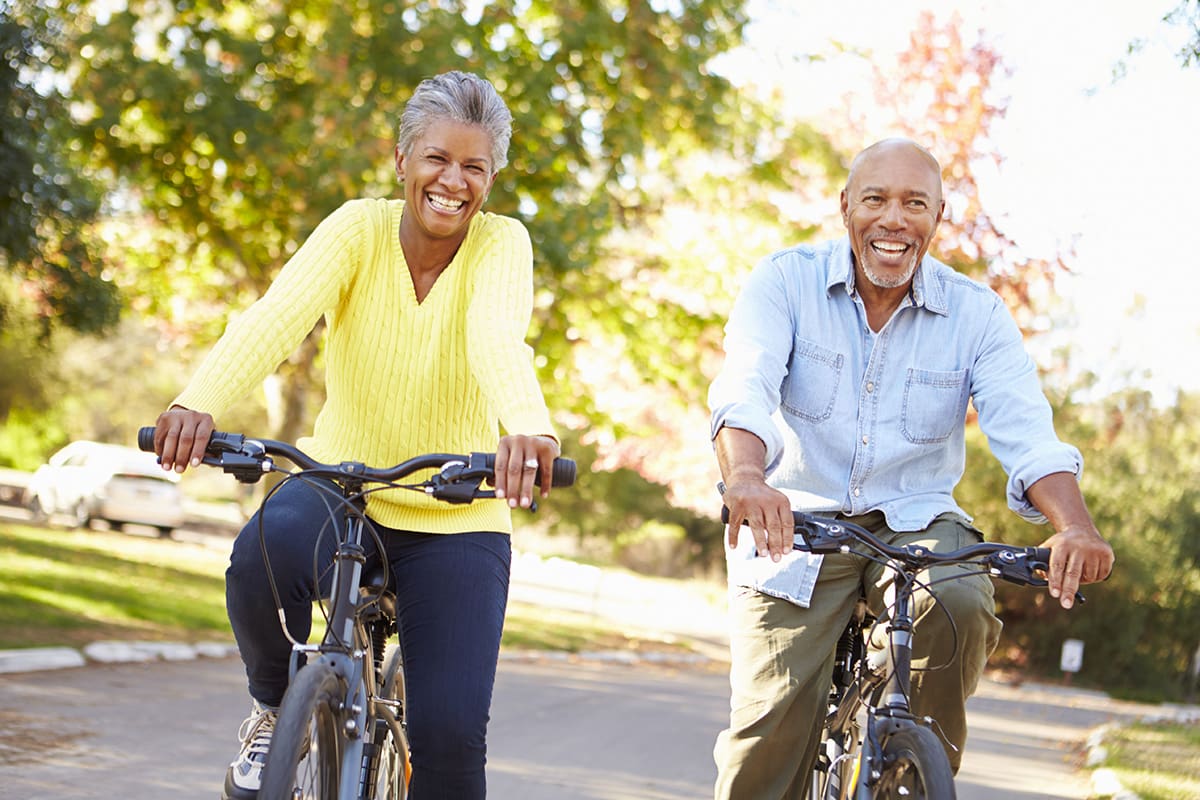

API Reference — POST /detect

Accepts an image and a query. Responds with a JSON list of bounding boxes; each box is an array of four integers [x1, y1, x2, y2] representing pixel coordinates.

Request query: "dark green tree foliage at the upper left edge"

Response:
[[0, 0, 120, 335]]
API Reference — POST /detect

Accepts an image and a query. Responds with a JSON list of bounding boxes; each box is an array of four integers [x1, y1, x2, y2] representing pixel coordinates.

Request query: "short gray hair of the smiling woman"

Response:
[[396, 71, 512, 172]]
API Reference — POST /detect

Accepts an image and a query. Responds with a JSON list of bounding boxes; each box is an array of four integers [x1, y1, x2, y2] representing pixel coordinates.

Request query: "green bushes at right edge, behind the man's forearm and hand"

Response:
[[959, 390, 1200, 697]]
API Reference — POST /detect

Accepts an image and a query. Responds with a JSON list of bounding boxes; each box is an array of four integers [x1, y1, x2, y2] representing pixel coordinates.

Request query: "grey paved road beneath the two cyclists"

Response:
[[0, 658, 1161, 800]]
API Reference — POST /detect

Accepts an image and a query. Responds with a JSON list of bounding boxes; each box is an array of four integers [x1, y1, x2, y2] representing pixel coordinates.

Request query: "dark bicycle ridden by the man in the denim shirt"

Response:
[[721, 509, 1084, 800]]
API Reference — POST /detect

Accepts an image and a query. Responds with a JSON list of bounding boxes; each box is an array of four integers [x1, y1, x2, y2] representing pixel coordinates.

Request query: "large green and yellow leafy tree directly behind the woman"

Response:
[[60, 0, 744, 438]]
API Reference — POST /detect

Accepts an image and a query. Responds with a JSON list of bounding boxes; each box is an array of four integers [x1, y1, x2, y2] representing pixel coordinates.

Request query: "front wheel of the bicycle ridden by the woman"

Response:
[[258, 663, 346, 800]]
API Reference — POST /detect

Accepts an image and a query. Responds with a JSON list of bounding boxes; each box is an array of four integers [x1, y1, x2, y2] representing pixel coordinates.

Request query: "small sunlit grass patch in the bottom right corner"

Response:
[[1100, 722, 1200, 800]]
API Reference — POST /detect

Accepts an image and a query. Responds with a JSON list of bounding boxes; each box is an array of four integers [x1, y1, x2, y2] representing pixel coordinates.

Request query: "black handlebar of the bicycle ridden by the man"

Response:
[[721, 506, 1084, 594]]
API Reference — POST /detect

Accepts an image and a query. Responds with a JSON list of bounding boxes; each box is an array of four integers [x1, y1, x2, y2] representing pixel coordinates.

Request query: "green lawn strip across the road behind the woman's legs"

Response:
[[0, 521, 690, 654]]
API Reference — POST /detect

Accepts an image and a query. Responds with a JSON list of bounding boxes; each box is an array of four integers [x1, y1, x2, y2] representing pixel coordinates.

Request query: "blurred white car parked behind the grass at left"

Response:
[[25, 441, 184, 536]]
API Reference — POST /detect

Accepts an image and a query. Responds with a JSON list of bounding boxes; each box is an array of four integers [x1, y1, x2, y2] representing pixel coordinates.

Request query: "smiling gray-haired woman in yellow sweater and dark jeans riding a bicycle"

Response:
[[155, 72, 559, 800]]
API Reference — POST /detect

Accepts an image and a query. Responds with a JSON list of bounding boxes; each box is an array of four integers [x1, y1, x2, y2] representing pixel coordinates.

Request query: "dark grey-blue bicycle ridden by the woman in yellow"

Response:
[[138, 427, 575, 800]]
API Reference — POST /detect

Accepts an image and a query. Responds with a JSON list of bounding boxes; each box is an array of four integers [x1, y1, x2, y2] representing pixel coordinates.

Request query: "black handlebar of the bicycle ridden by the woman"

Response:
[[138, 427, 576, 501]]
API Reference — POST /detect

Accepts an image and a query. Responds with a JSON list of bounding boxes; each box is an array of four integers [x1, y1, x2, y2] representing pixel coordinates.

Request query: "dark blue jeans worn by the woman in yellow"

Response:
[[226, 481, 512, 800]]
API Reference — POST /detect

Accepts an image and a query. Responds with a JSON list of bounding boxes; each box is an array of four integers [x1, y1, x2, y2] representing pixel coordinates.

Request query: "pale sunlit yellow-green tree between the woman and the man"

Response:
[[540, 103, 840, 510]]
